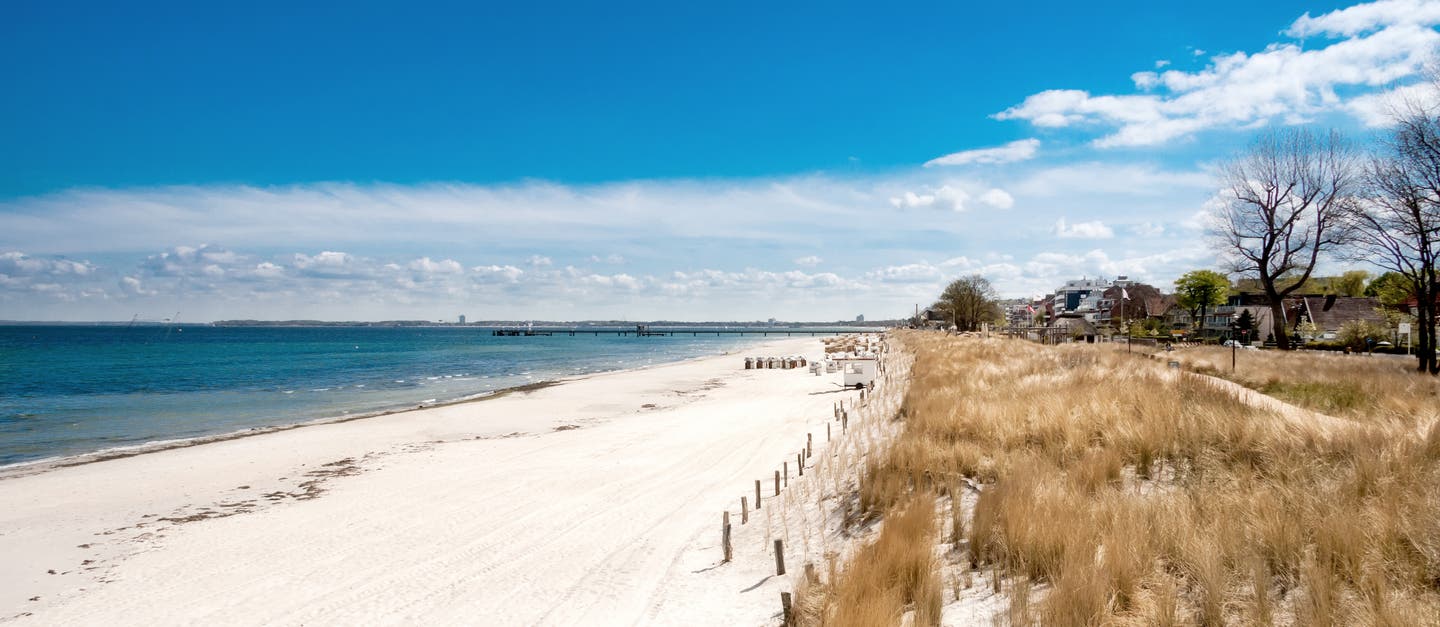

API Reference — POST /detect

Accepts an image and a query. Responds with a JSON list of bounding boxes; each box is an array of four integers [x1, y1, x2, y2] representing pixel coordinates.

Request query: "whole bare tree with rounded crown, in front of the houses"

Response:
[[1212, 128, 1361, 349]]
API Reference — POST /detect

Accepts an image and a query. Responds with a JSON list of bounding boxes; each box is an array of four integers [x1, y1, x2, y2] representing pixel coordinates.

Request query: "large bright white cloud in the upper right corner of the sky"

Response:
[[995, 0, 1440, 147]]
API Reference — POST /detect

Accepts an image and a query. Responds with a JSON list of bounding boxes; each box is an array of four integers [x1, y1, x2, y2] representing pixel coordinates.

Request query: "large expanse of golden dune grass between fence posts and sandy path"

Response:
[[808, 333, 1440, 626]]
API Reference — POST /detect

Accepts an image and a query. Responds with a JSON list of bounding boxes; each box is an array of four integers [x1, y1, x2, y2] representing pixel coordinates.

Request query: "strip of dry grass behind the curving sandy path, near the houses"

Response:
[[1169, 346, 1440, 425]]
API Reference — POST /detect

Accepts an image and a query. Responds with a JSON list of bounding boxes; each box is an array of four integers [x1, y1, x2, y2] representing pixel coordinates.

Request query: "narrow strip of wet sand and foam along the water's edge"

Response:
[[0, 339, 785, 481]]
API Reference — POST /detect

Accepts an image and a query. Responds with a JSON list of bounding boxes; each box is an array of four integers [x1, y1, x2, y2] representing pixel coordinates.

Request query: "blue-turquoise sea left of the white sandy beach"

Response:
[[0, 324, 840, 467]]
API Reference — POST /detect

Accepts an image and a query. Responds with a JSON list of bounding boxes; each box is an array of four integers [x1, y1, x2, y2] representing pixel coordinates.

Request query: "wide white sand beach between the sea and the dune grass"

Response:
[[0, 339, 855, 626]]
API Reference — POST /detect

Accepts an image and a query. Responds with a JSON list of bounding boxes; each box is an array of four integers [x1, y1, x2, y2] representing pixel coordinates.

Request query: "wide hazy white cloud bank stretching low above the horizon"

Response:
[[0, 163, 1232, 320]]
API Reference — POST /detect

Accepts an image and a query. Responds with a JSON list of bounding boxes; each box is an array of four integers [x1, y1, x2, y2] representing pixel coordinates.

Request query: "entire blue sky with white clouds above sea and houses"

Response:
[[0, 0, 1440, 321]]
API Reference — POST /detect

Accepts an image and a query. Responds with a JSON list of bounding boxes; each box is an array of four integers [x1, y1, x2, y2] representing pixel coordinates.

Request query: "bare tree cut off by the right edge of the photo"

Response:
[[1349, 91, 1440, 375]]
